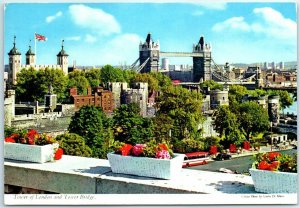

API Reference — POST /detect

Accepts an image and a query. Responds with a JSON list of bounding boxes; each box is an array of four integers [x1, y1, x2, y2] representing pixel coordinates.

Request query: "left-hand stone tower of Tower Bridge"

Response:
[[140, 33, 160, 73]]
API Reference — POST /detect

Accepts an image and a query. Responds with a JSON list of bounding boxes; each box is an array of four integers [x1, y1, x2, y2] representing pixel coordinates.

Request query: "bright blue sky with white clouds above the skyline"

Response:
[[4, 2, 297, 66]]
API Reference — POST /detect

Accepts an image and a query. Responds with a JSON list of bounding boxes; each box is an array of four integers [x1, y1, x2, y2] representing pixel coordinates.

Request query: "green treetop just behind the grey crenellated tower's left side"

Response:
[[101, 65, 124, 83]]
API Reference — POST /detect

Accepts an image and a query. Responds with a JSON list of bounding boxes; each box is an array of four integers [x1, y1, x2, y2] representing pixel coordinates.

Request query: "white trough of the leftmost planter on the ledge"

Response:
[[4, 142, 53, 163]]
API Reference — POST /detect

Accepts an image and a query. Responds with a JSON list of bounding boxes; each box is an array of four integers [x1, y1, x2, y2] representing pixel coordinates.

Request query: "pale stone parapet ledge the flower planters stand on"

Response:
[[4, 155, 256, 194]]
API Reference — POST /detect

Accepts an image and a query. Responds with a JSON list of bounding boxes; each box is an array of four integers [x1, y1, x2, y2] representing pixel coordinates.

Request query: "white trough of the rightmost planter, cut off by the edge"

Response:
[[249, 169, 298, 194]]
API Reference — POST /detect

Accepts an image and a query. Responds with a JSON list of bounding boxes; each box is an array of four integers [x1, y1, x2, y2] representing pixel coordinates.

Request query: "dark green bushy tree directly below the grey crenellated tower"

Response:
[[112, 103, 153, 144]]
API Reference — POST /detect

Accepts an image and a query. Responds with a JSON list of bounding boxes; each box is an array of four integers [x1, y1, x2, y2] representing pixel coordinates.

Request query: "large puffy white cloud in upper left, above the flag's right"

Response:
[[69, 5, 121, 35]]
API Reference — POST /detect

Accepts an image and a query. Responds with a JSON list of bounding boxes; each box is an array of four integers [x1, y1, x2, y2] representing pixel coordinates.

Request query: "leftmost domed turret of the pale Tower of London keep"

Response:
[[8, 36, 21, 88]]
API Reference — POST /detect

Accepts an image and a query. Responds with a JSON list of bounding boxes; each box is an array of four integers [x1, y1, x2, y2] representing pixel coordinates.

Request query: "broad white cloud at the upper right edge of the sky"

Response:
[[212, 7, 297, 41]]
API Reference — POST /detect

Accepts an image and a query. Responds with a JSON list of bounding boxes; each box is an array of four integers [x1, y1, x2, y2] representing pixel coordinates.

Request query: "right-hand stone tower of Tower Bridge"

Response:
[[193, 36, 211, 82]]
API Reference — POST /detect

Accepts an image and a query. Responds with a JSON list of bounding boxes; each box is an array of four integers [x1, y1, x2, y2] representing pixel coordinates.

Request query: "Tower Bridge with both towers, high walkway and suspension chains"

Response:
[[130, 33, 259, 85]]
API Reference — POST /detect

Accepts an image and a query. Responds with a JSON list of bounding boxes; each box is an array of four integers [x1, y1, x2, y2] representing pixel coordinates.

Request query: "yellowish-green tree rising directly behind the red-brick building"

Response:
[[68, 70, 90, 95]]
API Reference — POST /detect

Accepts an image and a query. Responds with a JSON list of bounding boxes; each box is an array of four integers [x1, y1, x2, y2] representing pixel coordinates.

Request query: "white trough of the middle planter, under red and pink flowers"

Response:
[[107, 153, 184, 179]]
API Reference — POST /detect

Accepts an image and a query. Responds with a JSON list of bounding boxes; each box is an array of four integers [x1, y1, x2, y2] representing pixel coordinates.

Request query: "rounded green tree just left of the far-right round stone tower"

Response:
[[238, 102, 270, 139]]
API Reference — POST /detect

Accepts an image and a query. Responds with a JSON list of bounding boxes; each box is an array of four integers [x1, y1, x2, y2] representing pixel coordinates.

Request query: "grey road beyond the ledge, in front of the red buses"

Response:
[[188, 149, 297, 173]]
